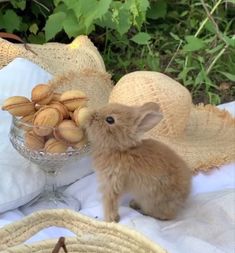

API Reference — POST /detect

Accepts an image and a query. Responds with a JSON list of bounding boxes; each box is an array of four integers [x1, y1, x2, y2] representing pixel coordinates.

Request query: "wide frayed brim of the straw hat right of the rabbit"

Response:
[[148, 105, 235, 173]]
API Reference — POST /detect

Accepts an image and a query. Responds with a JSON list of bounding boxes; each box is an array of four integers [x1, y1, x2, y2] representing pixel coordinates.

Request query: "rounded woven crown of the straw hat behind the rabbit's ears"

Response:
[[109, 71, 192, 136]]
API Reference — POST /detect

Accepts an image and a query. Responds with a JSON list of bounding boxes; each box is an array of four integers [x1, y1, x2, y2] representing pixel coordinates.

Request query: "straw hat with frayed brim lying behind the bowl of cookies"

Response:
[[0, 34, 113, 108]]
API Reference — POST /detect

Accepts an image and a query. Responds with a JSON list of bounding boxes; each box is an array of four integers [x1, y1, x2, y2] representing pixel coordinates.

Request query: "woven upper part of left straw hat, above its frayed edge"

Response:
[[0, 35, 105, 75]]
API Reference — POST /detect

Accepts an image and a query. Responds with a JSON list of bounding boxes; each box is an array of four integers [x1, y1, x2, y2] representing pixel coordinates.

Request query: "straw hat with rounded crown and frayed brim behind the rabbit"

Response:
[[109, 71, 235, 172]]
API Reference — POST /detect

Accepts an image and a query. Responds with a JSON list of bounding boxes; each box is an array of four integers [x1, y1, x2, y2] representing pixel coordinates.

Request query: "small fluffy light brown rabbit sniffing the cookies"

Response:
[[84, 102, 192, 222]]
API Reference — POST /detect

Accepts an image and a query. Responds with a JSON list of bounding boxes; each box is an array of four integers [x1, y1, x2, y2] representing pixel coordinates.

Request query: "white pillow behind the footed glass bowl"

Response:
[[0, 58, 92, 213]]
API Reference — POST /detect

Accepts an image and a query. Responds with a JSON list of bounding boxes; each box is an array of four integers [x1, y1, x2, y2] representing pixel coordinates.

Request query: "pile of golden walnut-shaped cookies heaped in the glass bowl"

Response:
[[2, 84, 88, 153]]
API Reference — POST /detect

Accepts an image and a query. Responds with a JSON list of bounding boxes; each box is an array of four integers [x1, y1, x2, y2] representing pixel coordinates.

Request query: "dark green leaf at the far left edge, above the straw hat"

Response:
[[0, 10, 22, 33]]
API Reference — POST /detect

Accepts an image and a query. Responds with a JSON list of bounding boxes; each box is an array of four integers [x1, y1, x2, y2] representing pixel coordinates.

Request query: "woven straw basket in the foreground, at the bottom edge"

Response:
[[0, 209, 167, 253]]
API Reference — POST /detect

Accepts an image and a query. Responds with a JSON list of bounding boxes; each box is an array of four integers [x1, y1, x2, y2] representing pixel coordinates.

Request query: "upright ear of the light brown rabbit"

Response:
[[137, 102, 163, 132]]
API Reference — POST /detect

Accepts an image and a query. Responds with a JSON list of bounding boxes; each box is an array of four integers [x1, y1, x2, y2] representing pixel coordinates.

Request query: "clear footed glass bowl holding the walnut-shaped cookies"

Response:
[[9, 116, 90, 213]]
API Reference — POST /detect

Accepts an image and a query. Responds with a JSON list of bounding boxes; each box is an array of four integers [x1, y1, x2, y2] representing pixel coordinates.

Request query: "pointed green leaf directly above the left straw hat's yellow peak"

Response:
[[63, 10, 82, 38]]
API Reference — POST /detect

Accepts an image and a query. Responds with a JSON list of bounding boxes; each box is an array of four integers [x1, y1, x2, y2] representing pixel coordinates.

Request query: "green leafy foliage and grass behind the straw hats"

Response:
[[0, 0, 235, 104]]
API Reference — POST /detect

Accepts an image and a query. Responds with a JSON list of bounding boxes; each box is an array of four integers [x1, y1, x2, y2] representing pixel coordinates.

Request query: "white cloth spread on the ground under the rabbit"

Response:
[[0, 164, 235, 253]]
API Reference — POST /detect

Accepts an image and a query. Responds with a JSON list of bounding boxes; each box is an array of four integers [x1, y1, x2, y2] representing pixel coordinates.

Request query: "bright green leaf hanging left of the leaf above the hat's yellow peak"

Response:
[[45, 12, 66, 41]]
